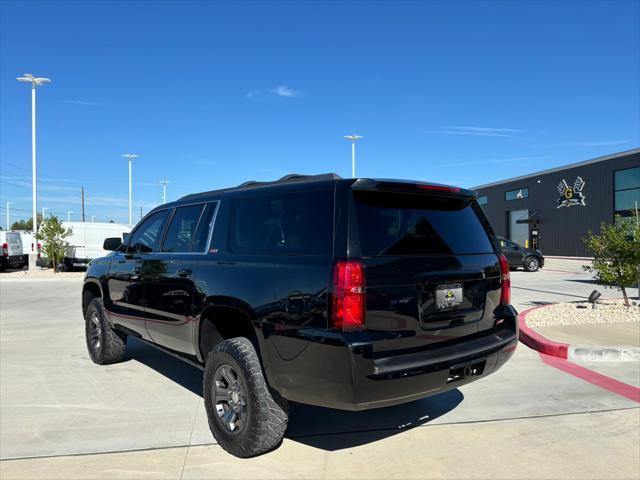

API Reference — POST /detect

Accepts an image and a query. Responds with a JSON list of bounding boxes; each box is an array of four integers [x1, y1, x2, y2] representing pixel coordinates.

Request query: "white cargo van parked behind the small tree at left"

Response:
[[40, 222, 131, 271]]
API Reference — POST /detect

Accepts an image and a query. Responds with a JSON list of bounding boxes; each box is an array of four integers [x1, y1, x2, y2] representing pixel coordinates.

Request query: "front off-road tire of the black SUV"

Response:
[[84, 298, 127, 365]]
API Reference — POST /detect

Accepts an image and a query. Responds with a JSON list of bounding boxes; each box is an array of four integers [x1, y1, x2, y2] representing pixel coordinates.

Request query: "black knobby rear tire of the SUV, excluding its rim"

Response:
[[204, 337, 288, 458]]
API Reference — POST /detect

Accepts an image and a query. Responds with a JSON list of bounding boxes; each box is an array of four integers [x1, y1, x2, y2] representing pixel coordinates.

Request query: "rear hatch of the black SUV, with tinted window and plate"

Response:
[[349, 180, 500, 357]]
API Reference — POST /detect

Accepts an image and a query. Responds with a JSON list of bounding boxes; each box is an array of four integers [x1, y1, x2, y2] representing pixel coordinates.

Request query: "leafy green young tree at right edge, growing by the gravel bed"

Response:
[[583, 214, 640, 307]]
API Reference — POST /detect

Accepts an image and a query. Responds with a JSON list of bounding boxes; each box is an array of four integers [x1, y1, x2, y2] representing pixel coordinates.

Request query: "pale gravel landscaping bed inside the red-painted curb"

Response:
[[527, 299, 640, 328]]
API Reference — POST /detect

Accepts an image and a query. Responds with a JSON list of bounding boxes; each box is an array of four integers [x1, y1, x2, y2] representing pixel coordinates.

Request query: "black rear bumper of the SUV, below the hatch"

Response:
[[263, 307, 518, 410]]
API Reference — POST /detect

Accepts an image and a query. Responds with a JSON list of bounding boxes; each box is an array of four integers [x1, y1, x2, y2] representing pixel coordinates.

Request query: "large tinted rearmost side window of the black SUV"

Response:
[[230, 191, 333, 255]]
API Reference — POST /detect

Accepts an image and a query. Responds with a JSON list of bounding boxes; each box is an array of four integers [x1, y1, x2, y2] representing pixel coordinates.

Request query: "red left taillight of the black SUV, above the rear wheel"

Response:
[[331, 261, 365, 330]]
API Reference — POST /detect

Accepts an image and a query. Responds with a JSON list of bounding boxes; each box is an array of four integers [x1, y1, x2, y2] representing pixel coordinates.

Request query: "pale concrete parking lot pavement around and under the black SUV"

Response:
[[0, 260, 640, 479]]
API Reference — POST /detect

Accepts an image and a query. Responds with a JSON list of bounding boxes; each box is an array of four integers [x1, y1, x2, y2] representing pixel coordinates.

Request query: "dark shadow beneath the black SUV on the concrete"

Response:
[[127, 338, 464, 451]]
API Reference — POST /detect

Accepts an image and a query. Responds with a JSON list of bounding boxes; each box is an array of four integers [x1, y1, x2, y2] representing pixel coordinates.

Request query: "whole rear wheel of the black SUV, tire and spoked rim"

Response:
[[204, 337, 288, 457]]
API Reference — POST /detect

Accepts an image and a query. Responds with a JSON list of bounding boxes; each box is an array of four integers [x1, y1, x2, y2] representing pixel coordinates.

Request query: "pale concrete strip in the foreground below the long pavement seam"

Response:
[[0, 409, 640, 480]]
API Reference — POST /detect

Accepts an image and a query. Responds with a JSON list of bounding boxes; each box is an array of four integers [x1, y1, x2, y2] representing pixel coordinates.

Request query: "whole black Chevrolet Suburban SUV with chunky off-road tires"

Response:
[[82, 174, 518, 457]]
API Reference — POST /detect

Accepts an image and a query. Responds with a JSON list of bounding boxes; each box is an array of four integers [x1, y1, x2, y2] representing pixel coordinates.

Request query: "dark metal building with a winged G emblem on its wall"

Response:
[[473, 148, 640, 256]]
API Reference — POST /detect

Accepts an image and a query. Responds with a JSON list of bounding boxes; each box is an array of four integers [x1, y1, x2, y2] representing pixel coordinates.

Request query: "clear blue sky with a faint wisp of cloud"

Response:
[[0, 1, 640, 226]]
